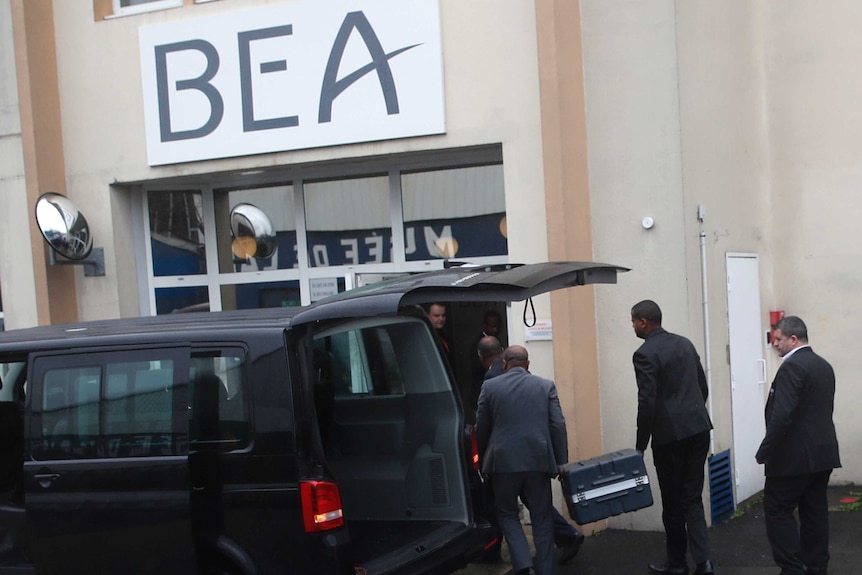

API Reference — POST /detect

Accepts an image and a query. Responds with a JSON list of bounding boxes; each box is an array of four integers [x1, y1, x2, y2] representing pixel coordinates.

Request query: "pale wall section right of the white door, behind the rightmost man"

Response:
[[765, 0, 862, 483]]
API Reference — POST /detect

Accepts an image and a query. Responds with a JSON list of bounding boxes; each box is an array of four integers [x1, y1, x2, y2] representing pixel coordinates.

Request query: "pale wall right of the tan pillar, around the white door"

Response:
[[582, 0, 862, 528]]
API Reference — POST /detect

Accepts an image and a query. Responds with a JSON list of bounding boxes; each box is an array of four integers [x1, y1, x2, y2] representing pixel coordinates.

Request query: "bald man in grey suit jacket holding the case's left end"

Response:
[[476, 345, 568, 575]]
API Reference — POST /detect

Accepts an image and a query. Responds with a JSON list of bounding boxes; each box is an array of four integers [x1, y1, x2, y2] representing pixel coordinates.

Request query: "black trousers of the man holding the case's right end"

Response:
[[652, 431, 710, 565]]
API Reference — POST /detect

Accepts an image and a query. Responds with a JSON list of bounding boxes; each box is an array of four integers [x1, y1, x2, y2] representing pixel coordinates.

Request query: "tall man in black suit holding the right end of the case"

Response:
[[631, 300, 714, 575]]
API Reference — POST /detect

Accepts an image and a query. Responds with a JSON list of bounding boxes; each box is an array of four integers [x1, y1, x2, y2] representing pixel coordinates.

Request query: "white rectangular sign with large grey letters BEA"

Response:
[[139, 0, 445, 166]]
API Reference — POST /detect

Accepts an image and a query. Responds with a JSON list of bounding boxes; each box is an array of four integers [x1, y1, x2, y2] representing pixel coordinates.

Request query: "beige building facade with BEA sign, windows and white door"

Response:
[[0, 0, 862, 529]]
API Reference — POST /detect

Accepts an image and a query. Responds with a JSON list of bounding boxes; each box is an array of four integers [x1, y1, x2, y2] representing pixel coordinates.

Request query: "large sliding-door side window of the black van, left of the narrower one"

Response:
[[33, 350, 188, 460]]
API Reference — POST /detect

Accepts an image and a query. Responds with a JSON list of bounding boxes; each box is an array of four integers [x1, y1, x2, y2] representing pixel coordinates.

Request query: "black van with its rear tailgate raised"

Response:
[[0, 262, 625, 575]]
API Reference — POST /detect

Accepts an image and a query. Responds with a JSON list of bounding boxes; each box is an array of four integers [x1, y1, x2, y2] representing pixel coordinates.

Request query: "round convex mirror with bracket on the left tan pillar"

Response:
[[36, 192, 105, 276]]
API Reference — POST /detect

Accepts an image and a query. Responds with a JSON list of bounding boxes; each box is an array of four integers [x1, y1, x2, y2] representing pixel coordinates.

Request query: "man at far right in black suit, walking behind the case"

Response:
[[755, 316, 841, 575]]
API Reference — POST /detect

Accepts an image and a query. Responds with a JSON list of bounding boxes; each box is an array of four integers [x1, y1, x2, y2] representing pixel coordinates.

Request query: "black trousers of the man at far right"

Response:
[[763, 470, 832, 575]]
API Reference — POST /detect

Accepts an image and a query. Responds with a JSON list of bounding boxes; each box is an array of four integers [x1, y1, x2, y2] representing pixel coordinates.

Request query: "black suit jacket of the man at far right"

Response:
[[756, 347, 841, 477]]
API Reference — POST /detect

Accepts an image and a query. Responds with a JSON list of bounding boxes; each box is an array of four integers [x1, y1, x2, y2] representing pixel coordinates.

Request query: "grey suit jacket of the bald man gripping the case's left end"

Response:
[[476, 367, 568, 475]]
